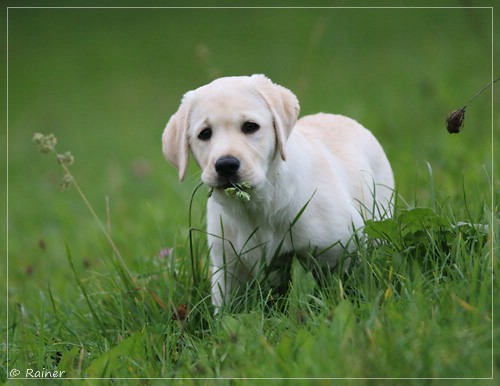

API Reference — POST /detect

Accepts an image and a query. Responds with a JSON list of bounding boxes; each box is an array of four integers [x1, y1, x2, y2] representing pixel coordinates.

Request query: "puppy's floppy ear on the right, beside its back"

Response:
[[251, 75, 300, 160]]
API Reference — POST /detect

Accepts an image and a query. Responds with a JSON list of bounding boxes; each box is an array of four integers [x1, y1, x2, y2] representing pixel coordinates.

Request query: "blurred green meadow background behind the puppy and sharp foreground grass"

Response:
[[1, 1, 500, 307]]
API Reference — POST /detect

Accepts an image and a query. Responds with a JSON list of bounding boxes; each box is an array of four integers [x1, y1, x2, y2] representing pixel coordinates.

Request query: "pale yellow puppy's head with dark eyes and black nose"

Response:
[[162, 75, 299, 189]]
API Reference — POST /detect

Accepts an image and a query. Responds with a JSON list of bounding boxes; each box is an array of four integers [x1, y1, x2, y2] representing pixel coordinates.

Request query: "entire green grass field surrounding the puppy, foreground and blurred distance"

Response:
[[0, 1, 500, 385]]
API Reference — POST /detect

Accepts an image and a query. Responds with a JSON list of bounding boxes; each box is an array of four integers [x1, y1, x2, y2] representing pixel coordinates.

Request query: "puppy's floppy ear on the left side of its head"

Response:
[[161, 92, 190, 181]]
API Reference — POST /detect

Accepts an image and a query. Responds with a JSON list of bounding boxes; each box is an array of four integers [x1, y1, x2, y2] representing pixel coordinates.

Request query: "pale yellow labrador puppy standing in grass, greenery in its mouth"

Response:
[[162, 75, 394, 308]]
